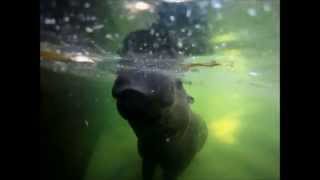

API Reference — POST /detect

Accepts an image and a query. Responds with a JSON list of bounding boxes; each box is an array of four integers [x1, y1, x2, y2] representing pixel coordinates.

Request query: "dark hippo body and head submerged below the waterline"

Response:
[[113, 70, 208, 180]]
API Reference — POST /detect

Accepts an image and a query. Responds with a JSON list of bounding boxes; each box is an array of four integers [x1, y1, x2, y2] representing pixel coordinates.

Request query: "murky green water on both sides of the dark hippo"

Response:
[[40, 1, 280, 180]]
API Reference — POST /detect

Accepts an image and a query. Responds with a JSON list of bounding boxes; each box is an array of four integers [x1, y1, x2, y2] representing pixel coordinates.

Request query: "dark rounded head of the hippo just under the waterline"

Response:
[[112, 70, 181, 123]]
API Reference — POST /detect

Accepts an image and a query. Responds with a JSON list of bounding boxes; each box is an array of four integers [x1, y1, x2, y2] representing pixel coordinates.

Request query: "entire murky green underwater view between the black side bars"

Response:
[[40, 0, 280, 180]]
